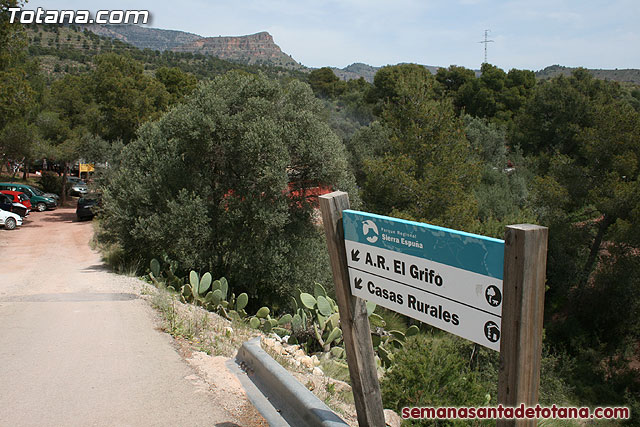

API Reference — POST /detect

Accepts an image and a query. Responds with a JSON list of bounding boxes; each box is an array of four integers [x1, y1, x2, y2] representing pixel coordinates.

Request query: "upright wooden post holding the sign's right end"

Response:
[[497, 224, 548, 427]]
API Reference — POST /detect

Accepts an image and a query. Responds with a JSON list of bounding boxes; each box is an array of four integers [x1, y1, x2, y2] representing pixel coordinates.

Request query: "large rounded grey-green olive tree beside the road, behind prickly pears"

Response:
[[103, 72, 356, 304]]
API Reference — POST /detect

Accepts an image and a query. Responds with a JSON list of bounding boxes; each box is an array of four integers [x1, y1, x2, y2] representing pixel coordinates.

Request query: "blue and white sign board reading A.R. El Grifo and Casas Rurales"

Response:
[[343, 210, 504, 351]]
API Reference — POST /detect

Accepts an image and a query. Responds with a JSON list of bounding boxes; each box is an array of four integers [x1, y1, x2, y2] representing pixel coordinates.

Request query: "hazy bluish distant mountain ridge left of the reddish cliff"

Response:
[[84, 24, 202, 51]]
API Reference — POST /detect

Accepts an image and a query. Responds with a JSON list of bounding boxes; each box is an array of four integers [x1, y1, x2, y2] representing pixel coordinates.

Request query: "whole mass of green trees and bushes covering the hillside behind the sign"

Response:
[[0, 5, 640, 426]]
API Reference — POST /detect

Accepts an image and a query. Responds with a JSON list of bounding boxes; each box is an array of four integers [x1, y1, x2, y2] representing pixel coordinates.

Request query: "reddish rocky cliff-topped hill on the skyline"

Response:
[[171, 31, 301, 68]]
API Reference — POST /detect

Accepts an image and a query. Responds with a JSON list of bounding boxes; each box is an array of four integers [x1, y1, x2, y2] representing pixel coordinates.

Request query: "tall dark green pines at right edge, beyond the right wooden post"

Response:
[[518, 70, 640, 414]]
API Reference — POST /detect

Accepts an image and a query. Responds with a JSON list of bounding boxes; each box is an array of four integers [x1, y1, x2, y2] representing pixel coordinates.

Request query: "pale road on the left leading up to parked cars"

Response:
[[0, 208, 260, 427]]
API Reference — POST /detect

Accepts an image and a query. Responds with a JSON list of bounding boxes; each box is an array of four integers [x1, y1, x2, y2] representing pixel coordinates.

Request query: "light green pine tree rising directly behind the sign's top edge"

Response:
[[363, 66, 477, 228]]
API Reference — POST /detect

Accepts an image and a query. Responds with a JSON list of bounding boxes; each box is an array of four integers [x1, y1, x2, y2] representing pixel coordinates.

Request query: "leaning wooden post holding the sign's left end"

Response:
[[319, 191, 385, 427]]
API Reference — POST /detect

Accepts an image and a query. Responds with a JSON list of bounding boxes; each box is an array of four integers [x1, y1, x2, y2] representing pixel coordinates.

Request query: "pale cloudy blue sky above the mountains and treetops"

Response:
[[24, 0, 640, 71]]
